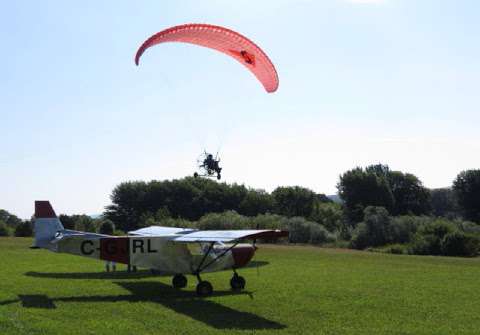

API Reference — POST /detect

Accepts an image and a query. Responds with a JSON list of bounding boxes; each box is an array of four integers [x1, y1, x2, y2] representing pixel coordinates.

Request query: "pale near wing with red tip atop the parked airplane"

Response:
[[173, 230, 288, 243]]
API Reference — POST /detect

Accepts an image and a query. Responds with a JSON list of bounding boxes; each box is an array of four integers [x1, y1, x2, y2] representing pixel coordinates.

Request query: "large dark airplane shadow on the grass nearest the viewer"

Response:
[[0, 282, 286, 330]]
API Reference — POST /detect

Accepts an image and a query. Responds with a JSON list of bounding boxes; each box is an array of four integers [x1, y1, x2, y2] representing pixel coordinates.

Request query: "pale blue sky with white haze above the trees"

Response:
[[0, 0, 480, 218]]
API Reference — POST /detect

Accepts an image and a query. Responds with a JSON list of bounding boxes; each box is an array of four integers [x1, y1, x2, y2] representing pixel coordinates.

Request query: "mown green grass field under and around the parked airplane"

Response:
[[0, 238, 480, 335]]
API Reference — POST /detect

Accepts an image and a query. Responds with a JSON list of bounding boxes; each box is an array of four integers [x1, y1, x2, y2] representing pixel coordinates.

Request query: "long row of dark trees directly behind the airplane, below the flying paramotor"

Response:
[[104, 177, 332, 231]]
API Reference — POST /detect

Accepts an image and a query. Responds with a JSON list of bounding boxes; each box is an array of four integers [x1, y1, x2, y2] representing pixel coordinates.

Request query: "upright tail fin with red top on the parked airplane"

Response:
[[34, 201, 64, 249]]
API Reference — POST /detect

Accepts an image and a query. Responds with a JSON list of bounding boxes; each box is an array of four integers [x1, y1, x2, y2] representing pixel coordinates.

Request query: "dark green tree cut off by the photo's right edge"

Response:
[[453, 170, 480, 222]]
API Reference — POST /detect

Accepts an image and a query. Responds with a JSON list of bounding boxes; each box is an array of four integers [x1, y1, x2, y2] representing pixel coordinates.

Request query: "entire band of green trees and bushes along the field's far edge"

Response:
[[0, 164, 480, 256]]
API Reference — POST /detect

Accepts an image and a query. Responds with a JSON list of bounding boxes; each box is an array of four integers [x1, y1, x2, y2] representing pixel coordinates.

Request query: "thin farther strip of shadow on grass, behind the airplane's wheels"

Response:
[[25, 261, 269, 280]]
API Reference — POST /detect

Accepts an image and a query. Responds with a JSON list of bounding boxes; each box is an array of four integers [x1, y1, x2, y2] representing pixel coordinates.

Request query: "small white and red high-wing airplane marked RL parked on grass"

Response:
[[32, 201, 288, 296]]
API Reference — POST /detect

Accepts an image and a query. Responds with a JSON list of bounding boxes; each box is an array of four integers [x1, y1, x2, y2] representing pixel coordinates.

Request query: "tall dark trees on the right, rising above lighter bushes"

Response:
[[337, 164, 480, 223]]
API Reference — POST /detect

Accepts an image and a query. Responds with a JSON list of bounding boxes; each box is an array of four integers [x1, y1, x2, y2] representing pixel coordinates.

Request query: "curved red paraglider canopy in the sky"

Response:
[[135, 24, 278, 93]]
